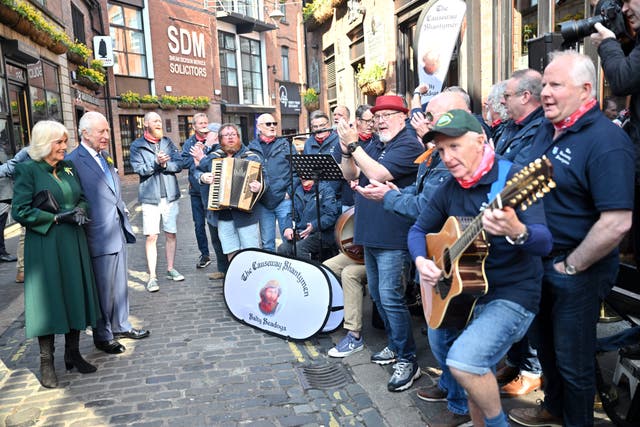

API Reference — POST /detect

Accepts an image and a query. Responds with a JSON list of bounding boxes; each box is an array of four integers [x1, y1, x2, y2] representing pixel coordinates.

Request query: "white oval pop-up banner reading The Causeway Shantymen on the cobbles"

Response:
[[224, 249, 344, 340]]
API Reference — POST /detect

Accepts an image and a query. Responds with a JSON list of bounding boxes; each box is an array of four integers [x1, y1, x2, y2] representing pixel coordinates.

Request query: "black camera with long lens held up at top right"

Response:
[[558, 0, 626, 45]]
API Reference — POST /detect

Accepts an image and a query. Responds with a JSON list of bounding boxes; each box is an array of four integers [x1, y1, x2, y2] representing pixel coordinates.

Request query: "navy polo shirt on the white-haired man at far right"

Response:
[[530, 105, 635, 255]]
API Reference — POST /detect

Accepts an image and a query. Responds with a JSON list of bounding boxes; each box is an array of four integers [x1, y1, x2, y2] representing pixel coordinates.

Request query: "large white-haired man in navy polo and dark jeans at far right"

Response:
[[509, 51, 634, 426]]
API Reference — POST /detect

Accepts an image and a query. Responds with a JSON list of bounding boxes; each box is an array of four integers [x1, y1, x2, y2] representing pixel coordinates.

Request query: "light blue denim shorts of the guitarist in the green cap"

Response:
[[447, 299, 535, 375]]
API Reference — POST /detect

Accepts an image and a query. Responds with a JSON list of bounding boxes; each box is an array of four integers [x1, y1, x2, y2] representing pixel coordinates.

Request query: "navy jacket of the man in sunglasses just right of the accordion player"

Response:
[[249, 137, 298, 210]]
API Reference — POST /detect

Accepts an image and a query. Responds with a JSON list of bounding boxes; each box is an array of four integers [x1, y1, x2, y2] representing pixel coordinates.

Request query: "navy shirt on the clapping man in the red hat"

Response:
[[354, 128, 424, 250]]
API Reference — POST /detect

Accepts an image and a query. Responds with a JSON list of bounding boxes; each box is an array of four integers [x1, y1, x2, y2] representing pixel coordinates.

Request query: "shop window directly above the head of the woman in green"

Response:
[[27, 61, 62, 123]]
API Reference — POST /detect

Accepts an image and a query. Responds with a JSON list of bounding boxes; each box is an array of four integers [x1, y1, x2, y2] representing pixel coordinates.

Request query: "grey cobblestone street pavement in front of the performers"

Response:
[[0, 174, 624, 427]]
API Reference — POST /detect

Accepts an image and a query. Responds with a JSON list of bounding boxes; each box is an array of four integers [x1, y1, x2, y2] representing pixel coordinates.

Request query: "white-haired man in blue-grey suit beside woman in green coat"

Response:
[[67, 112, 149, 354]]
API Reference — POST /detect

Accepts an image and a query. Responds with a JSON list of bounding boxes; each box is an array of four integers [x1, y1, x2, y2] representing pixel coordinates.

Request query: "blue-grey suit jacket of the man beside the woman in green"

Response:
[[67, 144, 136, 257]]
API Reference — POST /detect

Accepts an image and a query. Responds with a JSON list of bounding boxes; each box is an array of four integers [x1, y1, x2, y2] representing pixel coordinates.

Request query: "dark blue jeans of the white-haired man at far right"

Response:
[[530, 256, 618, 426]]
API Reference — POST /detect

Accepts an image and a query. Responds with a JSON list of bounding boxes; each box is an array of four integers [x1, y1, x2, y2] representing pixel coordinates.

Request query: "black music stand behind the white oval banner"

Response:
[[289, 154, 344, 261]]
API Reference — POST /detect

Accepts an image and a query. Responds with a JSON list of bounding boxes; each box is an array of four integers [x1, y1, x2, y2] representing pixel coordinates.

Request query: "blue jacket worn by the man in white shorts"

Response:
[[129, 136, 182, 205]]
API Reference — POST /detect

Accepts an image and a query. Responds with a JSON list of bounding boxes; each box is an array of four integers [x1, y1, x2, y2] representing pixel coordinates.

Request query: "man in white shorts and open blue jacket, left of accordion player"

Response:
[[129, 112, 184, 292]]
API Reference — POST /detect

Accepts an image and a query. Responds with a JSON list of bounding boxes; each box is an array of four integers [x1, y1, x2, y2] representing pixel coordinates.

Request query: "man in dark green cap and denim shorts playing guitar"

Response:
[[408, 110, 551, 426]]
